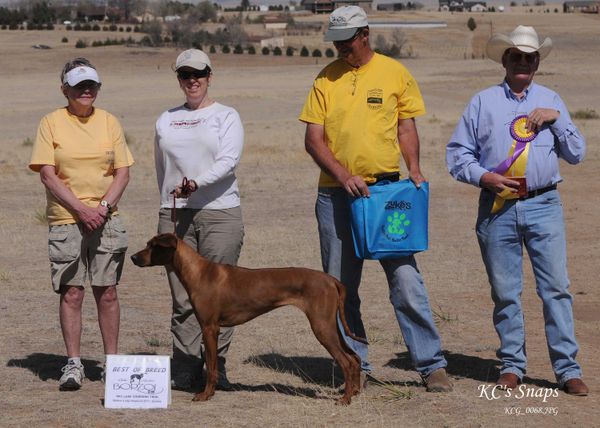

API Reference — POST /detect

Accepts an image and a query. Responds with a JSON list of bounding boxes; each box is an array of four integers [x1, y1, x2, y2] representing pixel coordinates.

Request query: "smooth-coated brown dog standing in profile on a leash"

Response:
[[131, 233, 367, 404]]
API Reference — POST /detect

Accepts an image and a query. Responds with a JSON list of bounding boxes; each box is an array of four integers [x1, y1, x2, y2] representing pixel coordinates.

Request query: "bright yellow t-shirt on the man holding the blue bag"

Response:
[[300, 53, 425, 187]]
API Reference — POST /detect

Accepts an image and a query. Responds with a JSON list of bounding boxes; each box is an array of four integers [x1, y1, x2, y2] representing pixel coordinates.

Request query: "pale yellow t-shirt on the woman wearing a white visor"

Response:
[[29, 108, 133, 225]]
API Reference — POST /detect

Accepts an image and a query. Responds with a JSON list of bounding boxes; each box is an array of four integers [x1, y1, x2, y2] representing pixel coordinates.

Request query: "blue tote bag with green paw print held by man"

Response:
[[350, 179, 429, 260]]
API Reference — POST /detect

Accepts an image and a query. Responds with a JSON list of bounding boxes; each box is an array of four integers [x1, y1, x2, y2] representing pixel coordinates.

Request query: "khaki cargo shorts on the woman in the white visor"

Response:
[[48, 216, 127, 293]]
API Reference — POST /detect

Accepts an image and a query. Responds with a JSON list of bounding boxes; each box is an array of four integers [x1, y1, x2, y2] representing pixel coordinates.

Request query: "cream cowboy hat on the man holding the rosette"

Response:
[[486, 25, 552, 64]]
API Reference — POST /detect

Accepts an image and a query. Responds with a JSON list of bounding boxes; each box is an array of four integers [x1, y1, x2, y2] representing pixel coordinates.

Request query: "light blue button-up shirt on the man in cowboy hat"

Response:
[[446, 81, 585, 190]]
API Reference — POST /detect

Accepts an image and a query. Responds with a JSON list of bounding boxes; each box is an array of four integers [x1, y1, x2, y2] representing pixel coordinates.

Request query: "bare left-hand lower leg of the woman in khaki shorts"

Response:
[[58, 286, 85, 358]]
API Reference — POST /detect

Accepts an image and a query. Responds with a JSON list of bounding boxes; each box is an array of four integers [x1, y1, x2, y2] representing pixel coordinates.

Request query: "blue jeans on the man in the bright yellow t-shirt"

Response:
[[315, 188, 447, 377]]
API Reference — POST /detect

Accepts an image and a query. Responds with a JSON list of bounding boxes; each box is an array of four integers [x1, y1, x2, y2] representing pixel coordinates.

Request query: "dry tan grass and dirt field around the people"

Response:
[[0, 13, 600, 427]]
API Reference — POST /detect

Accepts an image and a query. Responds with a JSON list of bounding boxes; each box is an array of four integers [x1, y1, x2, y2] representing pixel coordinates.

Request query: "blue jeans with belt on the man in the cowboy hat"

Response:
[[477, 190, 581, 385]]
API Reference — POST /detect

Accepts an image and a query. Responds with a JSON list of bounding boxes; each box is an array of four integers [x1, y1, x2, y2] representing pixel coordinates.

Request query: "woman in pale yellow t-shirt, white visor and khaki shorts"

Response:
[[29, 58, 133, 390]]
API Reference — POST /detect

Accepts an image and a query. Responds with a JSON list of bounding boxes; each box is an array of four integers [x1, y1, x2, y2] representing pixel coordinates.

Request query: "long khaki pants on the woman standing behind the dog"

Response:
[[158, 207, 244, 371]]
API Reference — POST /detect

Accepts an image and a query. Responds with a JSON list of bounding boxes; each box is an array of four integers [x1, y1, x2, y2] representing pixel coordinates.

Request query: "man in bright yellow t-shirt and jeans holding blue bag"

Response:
[[300, 6, 452, 392]]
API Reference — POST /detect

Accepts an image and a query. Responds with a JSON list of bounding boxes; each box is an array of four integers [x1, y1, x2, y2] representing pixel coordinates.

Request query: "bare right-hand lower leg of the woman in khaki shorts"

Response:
[[92, 285, 121, 354]]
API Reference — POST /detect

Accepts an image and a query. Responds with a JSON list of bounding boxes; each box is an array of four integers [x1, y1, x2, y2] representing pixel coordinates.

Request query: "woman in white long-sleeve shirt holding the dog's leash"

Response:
[[154, 49, 244, 389]]
